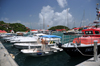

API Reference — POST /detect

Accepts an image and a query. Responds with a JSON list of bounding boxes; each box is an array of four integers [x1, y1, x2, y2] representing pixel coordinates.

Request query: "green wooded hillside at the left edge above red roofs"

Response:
[[0, 21, 29, 32]]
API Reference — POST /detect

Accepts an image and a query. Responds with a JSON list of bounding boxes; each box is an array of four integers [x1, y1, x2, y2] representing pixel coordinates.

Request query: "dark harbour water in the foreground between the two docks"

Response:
[[2, 33, 90, 66]]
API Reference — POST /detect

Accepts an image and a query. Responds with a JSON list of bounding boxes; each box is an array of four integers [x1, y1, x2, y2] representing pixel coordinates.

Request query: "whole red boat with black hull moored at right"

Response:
[[61, 24, 100, 56]]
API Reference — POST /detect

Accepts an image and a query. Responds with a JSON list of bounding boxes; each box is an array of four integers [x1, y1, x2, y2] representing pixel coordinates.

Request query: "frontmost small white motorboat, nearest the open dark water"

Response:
[[21, 46, 63, 57]]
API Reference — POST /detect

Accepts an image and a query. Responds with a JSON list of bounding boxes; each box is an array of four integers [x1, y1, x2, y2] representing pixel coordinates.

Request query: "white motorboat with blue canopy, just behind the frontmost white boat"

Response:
[[14, 35, 61, 49]]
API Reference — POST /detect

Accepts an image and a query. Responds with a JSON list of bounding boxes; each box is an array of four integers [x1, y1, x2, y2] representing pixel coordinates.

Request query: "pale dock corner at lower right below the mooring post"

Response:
[[76, 55, 100, 66]]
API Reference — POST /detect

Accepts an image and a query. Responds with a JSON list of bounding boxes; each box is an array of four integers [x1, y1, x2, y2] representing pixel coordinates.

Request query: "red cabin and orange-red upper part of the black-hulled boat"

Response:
[[73, 28, 100, 45]]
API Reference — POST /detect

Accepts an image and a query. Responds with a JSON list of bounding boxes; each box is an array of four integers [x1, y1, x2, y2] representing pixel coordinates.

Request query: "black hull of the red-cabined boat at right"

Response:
[[62, 45, 100, 57]]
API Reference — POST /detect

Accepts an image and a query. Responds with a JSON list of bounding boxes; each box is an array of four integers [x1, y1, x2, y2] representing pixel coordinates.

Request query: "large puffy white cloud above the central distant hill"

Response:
[[39, 5, 73, 28]]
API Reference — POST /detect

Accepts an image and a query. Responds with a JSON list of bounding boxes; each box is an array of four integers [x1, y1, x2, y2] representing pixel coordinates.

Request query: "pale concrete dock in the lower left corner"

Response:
[[0, 42, 18, 66]]
